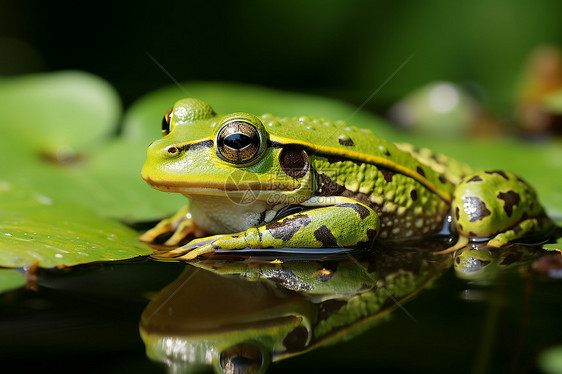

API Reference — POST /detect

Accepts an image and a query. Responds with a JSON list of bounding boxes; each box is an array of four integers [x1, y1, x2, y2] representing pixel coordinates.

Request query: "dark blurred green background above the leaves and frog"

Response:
[[4, 0, 562, 114]]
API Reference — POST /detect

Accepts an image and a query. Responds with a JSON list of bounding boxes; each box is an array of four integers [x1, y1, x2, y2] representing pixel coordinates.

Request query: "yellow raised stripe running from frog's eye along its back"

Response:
[[269, 134, 452, 203]]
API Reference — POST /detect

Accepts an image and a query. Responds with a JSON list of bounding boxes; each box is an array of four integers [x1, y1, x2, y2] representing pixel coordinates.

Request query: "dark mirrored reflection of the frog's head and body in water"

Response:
[[140, 250, 452, 373]]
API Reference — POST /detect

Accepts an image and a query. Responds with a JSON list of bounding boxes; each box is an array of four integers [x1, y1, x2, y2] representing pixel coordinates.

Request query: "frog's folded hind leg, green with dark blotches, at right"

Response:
[[452, 171, 554, 247]]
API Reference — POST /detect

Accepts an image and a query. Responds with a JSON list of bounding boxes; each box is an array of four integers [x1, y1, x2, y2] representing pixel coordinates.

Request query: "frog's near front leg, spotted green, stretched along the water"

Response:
[[158, 196, 380, 260]]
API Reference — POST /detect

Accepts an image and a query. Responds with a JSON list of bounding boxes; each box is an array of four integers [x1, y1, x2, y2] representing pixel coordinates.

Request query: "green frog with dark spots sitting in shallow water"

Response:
[[140, 98, 555, 261]]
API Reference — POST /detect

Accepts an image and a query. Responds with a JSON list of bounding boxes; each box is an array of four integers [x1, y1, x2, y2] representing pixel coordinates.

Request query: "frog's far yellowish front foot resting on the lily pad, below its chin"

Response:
[[139, 205, 204, 246]]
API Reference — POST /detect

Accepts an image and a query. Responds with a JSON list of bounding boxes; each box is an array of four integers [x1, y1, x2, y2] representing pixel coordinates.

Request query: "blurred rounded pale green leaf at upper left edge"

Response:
[[0, 71, 121, 156]]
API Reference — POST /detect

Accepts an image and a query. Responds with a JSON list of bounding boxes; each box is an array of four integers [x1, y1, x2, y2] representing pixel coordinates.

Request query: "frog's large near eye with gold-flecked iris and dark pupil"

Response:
[[217, 120, 260, 164]]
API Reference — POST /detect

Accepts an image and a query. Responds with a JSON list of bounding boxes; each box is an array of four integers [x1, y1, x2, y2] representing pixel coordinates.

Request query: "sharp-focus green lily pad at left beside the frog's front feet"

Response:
[[0, 182, 152, 268]]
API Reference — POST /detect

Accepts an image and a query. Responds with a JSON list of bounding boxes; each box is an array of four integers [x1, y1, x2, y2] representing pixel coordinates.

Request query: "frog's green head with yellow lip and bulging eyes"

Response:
[[142, 98, 314, 204]]
